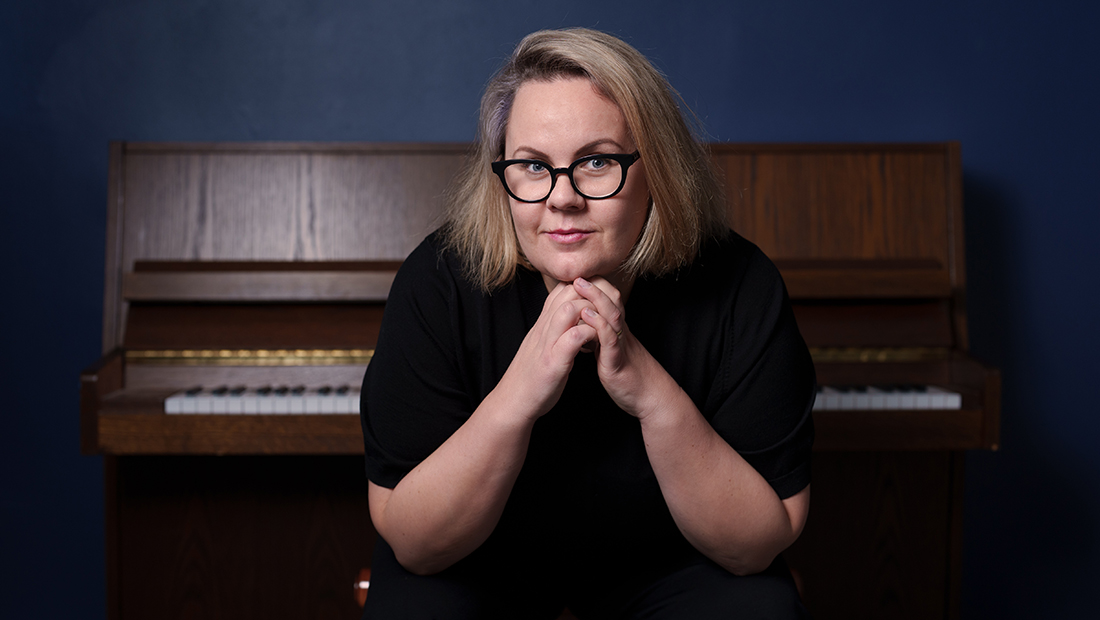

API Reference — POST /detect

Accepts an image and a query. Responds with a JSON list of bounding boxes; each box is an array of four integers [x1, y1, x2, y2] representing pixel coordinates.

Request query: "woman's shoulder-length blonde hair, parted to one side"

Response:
[[444, 29, 728, 291]]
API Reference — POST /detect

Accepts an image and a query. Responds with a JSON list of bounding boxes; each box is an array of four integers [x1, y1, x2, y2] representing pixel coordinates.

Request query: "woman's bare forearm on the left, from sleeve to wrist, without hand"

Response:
[[370, 392, 534, 575]]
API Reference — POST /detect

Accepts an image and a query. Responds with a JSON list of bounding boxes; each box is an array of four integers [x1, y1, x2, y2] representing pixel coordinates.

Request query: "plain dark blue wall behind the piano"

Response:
[[0, 0, 1100, 618]]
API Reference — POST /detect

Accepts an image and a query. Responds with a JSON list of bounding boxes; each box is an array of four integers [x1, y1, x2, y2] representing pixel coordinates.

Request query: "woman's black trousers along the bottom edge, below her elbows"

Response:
[[363, 539, 809, 620]]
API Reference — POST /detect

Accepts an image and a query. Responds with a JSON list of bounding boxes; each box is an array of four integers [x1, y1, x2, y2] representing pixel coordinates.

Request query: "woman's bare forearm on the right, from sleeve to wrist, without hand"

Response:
[[639, 375, 809, 574]]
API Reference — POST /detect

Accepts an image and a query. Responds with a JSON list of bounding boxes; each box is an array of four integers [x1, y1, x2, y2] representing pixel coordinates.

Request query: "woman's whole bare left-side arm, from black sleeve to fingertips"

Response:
[[369, 285, 595, 575]]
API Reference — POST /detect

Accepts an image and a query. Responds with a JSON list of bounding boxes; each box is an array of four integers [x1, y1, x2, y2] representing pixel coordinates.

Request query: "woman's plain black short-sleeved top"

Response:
[[362, 227, 815, 569]]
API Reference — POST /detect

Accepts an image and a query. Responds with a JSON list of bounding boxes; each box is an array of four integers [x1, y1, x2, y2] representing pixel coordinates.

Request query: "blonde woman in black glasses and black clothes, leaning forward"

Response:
[[362, 30, 814, 619]]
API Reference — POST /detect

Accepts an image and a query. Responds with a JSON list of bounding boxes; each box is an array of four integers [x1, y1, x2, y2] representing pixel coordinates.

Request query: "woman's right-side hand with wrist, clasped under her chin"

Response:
[[573, 277, 679, 418]]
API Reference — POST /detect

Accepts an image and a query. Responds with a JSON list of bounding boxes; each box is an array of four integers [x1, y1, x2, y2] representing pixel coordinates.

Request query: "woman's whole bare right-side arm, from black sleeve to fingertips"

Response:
[[575, 278, 810, 575]]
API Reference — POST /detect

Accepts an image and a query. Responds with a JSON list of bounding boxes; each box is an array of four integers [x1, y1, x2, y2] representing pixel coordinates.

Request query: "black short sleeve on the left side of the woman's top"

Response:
[[360, 235, 473, 488]]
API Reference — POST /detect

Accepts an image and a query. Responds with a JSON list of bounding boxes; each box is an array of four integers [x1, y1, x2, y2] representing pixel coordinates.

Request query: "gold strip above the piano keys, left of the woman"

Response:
[[125, 348, 374, 366]]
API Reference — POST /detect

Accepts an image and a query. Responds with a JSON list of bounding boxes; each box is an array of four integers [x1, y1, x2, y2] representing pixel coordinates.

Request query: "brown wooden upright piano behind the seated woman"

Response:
[[80, 143, 1000, 619]]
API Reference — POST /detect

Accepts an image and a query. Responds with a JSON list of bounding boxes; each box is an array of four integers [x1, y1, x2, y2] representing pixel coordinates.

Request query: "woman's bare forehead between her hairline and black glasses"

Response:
[[505, 78, 633, 156]]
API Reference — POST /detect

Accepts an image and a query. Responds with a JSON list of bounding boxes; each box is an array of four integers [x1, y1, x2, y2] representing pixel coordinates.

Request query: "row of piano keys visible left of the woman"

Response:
[[164, 386, 359, 413]]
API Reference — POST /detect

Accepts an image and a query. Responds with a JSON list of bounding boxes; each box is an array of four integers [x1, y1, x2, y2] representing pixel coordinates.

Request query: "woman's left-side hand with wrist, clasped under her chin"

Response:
[[494, 283, 596, 422]]
